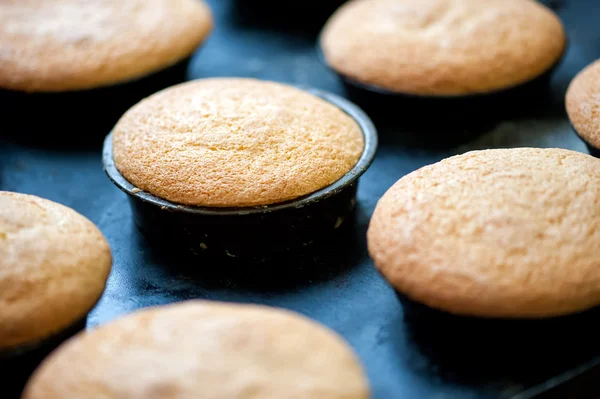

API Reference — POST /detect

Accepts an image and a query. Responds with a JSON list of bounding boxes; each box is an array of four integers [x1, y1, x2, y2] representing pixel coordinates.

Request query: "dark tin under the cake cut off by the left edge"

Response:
[[0, 313, 87, 397]]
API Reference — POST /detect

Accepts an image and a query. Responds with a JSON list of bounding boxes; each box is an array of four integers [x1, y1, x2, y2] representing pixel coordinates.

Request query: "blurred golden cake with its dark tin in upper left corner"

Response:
[[0, 0, 212, 137]]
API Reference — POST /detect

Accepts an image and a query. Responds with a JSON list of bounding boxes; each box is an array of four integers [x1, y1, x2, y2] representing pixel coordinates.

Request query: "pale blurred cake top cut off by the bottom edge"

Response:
[[23, 301, 369, 399]]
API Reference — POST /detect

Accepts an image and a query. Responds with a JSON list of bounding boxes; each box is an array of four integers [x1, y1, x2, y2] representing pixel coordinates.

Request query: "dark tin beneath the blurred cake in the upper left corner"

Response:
[[0, 57, 190, 143]]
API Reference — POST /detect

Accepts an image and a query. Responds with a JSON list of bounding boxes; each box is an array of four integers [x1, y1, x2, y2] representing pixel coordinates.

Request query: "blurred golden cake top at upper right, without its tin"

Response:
[[321, 0, 566, 96]]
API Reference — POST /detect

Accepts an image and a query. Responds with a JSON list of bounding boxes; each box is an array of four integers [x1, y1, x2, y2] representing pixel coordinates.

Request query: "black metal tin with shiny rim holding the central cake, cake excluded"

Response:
[[103, 89, 377, 262]]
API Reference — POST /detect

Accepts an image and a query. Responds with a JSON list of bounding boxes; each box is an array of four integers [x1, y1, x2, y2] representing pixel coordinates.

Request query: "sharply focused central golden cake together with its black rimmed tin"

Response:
[[104, 78, 377, 258]]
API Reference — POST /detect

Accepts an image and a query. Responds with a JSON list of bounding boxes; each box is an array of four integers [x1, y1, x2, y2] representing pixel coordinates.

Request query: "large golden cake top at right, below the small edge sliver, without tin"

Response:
[[368, 148, 600, 318]]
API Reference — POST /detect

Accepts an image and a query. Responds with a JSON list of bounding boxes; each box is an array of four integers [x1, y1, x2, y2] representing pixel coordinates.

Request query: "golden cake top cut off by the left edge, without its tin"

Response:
[[0, 191, 112, 352]]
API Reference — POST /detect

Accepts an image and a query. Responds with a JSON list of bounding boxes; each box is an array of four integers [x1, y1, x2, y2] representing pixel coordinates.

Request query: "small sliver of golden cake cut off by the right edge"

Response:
[[565, 61, 600, 157]]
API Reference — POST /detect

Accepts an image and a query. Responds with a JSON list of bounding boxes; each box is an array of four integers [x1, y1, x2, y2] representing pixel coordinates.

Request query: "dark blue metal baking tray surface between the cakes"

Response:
[[0, 0, 600, 399]]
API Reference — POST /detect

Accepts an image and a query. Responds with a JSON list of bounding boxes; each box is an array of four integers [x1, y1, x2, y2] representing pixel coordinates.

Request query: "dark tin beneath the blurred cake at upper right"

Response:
[[317, 42, 568, 126]]
